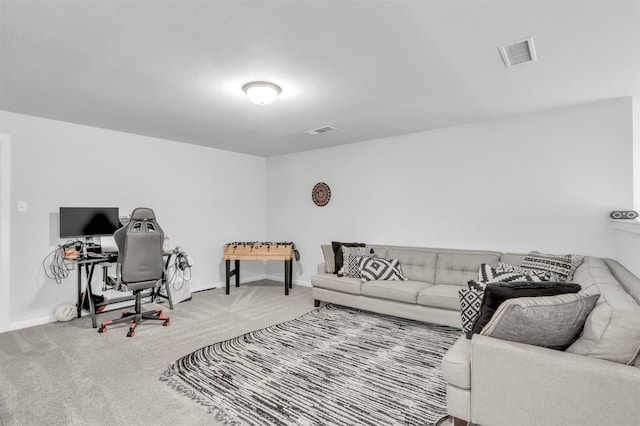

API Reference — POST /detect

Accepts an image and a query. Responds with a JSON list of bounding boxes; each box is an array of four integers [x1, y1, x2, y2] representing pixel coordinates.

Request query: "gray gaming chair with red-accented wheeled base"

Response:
[[98, 208, 169, 337]]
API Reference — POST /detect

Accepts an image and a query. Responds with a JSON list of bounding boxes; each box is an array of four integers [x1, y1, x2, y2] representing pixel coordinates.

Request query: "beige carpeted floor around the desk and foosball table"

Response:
[[0, 281, 314, 426]]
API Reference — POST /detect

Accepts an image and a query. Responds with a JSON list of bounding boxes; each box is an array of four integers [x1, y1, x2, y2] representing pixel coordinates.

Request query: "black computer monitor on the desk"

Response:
[[60, 207, 120, 238]]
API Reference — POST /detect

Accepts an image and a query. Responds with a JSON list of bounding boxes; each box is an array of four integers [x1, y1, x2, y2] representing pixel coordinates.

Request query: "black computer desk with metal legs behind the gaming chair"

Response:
[[70, 250, 176, 328]]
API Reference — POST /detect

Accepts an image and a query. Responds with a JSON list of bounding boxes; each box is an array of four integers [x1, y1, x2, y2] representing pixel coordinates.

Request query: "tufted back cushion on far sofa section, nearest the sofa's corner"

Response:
[[435, 251, 500, 286]]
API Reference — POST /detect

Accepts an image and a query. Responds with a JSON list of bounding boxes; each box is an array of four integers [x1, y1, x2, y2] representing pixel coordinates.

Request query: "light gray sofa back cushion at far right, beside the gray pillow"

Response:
[[567, 257, 640, 364]]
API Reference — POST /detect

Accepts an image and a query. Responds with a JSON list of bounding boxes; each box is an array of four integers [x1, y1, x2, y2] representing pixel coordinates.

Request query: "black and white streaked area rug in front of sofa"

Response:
[[161, 305, 460, 426]]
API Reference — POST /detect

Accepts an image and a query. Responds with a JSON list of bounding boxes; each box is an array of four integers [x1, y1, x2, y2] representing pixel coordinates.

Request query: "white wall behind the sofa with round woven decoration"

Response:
[[266, 98, 633, 283]]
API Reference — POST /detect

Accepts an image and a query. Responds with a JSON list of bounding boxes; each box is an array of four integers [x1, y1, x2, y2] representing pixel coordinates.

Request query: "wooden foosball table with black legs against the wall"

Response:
[[223, 241, 297, 296]]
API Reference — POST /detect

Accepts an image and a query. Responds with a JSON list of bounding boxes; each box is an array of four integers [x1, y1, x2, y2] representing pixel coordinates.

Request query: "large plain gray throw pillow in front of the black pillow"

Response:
[[480, 292, 600, 350]]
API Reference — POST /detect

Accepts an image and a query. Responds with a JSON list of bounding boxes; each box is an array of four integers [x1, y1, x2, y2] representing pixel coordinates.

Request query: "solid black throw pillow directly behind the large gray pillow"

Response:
[[467, 281, 581, 339]]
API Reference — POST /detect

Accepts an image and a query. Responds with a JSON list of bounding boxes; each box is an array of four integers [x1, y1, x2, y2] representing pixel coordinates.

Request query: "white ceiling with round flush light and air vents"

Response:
[[0, 0, 640, 156]]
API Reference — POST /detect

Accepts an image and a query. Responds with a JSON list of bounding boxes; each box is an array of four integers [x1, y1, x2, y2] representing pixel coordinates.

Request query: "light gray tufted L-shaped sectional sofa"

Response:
[[311, 245, 640, 426]]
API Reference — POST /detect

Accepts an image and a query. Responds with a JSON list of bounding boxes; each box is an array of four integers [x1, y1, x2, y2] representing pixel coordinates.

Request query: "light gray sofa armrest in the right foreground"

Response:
[[471, 335, 640, 426]]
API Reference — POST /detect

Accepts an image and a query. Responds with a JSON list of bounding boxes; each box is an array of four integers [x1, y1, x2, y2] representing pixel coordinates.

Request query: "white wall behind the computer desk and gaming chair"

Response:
[[0, 111, 266, 328]]
